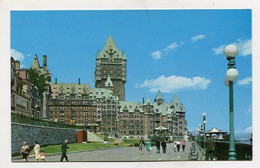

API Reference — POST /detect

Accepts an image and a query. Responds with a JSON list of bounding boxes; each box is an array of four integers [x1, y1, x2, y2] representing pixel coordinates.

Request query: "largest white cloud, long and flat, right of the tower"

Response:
[[137, 75, 211, 93]]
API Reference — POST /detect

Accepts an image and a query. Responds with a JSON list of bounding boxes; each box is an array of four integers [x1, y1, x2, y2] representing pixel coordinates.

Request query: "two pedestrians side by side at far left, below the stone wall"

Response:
[[20, 141, 46, 162]]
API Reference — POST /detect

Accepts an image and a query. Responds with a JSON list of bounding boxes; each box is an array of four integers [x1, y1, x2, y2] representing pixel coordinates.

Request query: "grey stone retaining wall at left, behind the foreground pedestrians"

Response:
[[11, 123, 76, 154]]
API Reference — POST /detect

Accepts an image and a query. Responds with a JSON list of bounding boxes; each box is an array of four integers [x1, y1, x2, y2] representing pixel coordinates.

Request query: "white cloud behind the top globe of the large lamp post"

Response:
[[213, 39, 252, 57]]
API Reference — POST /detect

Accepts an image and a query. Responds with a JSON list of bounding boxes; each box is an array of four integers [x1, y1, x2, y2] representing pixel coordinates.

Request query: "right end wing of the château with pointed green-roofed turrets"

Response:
[[142, 90, 187, 137]]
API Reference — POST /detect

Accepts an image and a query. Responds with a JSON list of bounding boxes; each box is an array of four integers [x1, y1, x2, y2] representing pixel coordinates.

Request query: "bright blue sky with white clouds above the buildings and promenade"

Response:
[[11, 10, 252, 138]]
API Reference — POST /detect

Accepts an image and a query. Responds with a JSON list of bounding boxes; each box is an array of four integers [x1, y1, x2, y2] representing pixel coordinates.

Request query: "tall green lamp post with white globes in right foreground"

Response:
[[224, 44, 238, 160]]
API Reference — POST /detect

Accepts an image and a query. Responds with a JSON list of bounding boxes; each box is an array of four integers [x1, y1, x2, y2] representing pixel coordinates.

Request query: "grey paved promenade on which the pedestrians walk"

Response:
[[13, 142, 201, 162]]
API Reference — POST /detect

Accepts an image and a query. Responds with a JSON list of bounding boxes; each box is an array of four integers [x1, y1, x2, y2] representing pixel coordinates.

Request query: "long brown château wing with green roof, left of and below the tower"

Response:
[[49, 79, 118, 136]]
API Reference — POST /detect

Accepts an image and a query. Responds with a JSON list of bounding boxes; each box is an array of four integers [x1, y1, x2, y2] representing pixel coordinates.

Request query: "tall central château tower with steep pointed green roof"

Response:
[[95, 35, 126, 101]]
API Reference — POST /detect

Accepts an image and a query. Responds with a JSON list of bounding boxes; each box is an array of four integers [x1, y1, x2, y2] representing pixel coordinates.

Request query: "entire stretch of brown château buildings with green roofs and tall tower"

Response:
[[11, 36, 187, 138]]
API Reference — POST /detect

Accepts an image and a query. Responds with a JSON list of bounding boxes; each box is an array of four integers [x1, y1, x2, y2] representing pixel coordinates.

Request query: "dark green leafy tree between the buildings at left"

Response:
[[29, 68, 47, 97]]
